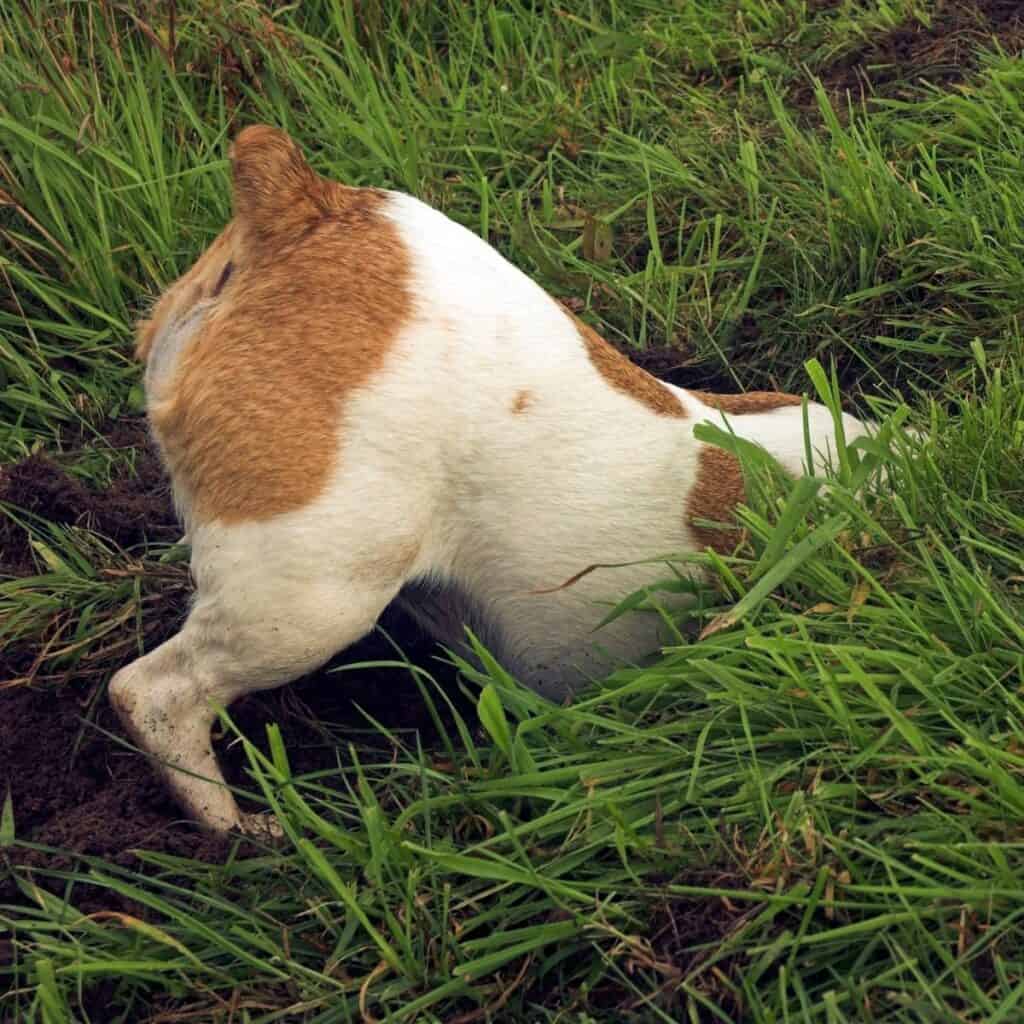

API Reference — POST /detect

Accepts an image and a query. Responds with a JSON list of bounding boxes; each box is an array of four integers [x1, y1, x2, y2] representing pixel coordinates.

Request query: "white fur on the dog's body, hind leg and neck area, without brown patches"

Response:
[[111, 195, 865, 829]]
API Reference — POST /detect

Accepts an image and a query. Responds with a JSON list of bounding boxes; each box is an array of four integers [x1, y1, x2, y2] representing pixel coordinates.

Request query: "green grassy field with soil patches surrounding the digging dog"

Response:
[[0, 0, 1024, 1024]]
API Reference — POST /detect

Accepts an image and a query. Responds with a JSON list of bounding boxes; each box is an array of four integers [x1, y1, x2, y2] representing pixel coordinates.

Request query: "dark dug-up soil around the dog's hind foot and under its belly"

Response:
[[0, 609, 464, 909]]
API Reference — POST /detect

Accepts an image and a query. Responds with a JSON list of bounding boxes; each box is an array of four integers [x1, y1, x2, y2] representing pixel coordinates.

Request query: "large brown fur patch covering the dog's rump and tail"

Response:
[[139, 126, 412, 522]]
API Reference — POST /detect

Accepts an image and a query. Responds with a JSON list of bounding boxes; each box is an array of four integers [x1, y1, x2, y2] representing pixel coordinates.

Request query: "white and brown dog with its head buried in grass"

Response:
[[110, 126, 880, 831]]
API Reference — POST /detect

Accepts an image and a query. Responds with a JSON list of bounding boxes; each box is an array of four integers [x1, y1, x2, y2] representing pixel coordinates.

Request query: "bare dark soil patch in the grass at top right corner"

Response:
[[796, 0, 1024, 106]]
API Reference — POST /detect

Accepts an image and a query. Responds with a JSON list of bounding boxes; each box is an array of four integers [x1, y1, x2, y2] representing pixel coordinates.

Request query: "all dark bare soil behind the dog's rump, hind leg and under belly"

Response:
[[0, 421, 472, 908]]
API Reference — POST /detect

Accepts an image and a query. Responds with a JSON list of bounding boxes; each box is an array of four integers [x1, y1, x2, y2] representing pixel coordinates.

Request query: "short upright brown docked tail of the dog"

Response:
[[229, 125, 325, 247]]
